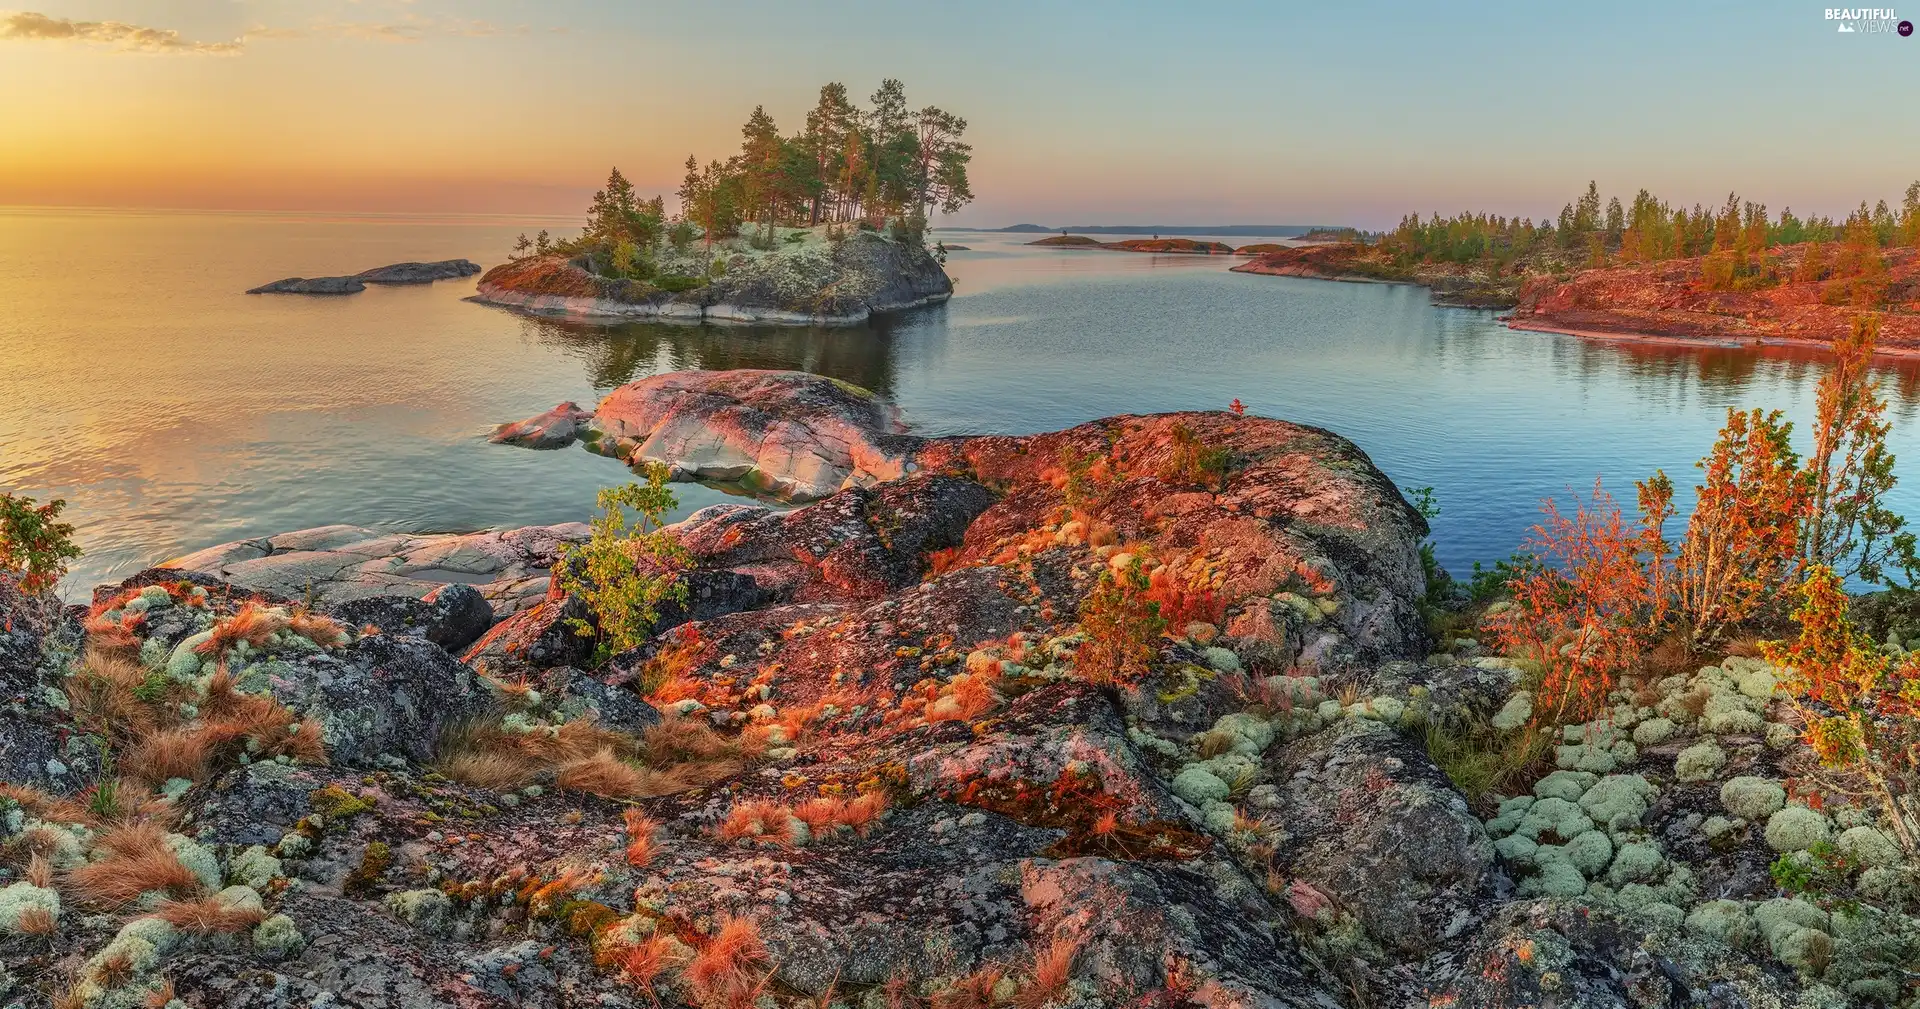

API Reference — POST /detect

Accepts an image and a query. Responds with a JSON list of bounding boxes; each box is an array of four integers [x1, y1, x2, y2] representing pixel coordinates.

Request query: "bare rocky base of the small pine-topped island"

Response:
[[474, 230, 952, 326]]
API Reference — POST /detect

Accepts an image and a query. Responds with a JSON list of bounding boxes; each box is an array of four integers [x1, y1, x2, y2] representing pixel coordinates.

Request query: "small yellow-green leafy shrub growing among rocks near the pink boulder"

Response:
[[561, 462, 689, 662]]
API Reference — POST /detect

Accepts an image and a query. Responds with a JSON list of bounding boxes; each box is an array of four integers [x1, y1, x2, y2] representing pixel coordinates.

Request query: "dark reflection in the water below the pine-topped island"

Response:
[[520, 317, 899, 399]]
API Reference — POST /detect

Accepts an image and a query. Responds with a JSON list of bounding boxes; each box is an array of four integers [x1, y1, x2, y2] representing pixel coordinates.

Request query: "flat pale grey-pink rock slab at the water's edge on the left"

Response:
[[161, 522, 588, 618]]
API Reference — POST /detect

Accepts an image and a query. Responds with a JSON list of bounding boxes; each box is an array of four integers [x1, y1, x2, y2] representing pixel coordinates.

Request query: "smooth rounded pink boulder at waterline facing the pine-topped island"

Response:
[[589, 368, 920, 501]]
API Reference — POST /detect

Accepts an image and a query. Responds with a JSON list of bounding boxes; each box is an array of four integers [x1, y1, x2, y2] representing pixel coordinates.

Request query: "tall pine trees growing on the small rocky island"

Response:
[[513, 79, 973, 278]]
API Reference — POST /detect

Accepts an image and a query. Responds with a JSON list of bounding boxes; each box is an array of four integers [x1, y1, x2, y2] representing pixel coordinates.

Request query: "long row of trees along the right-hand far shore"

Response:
[[1380, 182, 1920, 297]]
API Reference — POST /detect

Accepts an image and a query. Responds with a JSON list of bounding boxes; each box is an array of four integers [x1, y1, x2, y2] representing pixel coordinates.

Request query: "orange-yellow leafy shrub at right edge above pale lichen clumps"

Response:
[[1761, 566, 1920, 857]]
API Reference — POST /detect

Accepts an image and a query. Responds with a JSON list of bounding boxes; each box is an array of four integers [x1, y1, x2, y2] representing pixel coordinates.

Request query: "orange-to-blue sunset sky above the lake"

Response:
[[0, 0, 1920, 228]]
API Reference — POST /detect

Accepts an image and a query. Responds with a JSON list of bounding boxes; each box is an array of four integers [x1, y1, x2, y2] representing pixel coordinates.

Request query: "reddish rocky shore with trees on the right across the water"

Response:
[[1233, 182, 1920, 341]]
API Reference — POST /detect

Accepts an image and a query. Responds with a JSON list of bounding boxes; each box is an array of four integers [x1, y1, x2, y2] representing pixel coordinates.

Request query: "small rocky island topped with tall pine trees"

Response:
[[474, 79, 973, 326]]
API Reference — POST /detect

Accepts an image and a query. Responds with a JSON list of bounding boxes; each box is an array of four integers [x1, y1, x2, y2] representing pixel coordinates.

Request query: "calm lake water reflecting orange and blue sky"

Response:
[[0, 209, 1920, 591]]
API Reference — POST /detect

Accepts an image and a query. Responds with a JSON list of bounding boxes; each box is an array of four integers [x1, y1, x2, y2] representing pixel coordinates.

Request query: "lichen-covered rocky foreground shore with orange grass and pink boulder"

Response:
[[0, 372, 1920, 1009]]
